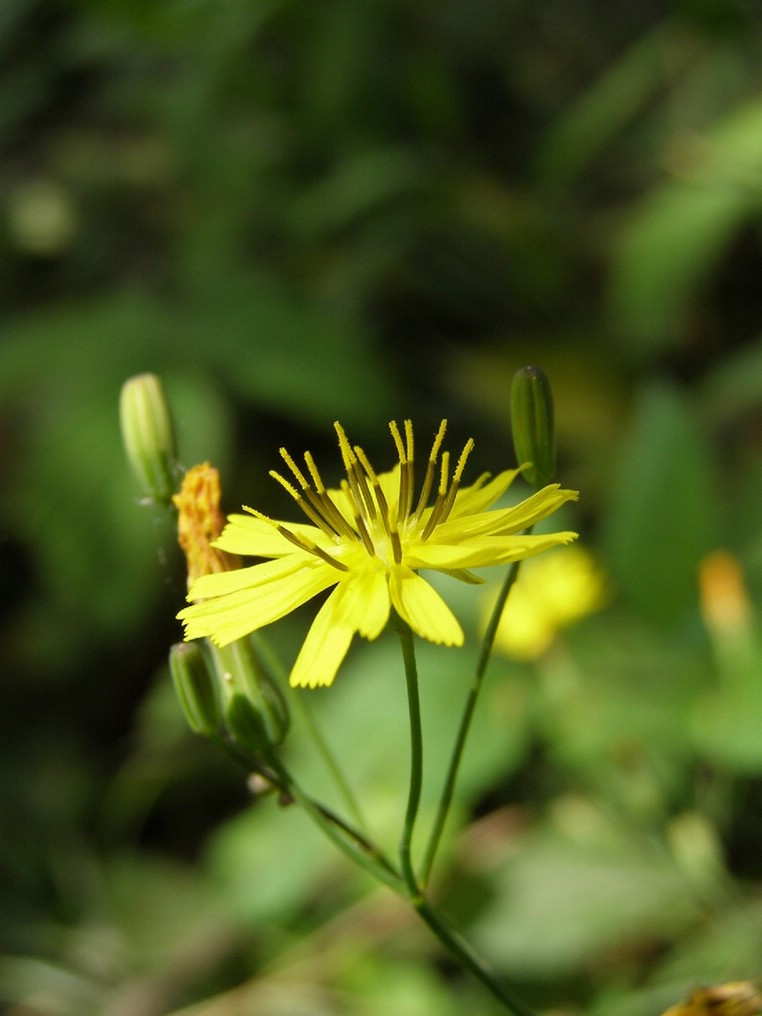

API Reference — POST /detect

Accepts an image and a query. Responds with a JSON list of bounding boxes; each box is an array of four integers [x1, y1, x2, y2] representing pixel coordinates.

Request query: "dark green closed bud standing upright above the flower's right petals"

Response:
[[511, 367, 556, 487]]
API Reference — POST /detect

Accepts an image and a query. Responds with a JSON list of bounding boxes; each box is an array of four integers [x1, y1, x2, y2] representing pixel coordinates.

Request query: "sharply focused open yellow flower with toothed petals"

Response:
[[178, 421, 577, 688]]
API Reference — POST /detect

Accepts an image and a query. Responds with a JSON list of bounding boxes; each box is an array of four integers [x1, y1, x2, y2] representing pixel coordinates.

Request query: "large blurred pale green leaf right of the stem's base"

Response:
[[472, 819, 700, 977]]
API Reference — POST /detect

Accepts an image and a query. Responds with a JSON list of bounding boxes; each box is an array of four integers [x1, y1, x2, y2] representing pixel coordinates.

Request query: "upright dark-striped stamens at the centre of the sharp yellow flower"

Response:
[[257, 420, 473, 571]]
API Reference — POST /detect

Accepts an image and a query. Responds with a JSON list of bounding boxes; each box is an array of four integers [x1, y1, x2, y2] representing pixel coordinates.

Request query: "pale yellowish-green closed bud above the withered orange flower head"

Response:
[[119, 374, 177, 504]]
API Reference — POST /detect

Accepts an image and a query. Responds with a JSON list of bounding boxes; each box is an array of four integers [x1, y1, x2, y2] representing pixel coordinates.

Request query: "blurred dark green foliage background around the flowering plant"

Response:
[[0, 0, 762, 1016]]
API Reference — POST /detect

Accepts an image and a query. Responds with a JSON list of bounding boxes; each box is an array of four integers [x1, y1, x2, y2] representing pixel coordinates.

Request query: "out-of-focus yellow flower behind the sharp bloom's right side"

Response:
[[495, 547, 608, 659]]
